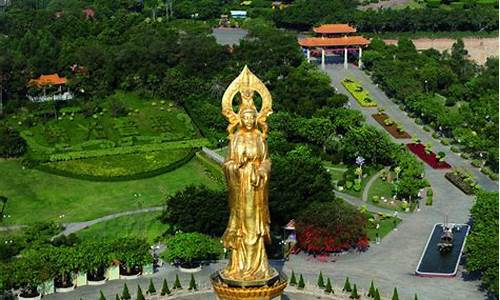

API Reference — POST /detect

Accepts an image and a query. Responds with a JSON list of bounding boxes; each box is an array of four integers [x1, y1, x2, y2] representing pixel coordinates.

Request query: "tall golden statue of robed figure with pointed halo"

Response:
[[221, 66, 277, 282]]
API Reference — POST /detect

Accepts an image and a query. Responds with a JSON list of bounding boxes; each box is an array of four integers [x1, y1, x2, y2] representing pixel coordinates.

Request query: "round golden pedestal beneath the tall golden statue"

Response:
[[210, 271, 288, 300]]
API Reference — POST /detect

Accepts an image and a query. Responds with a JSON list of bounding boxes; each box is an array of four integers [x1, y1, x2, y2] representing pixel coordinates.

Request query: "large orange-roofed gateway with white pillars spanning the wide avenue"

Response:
[[299, 24, 370, 69]]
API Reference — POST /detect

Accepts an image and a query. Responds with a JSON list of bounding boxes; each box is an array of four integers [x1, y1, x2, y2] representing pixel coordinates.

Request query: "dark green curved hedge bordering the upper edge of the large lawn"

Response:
[[35, 149, 196, 181]]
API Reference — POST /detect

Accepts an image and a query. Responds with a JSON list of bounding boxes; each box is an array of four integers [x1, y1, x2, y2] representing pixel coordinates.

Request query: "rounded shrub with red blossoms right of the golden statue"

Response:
[[296, 201, 368, 253]]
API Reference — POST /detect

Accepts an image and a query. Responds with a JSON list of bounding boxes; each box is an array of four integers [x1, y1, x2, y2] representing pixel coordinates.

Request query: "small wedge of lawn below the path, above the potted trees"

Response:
[[77, 212, 168, 244]]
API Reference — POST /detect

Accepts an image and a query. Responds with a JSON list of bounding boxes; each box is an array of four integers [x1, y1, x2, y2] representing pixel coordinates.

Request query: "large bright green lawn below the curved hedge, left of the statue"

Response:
[[0, 159, 221, 224]]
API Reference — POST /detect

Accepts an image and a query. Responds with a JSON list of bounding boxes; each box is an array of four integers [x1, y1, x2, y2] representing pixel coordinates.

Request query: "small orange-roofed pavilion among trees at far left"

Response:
[[27, 73, 73, 102]]
